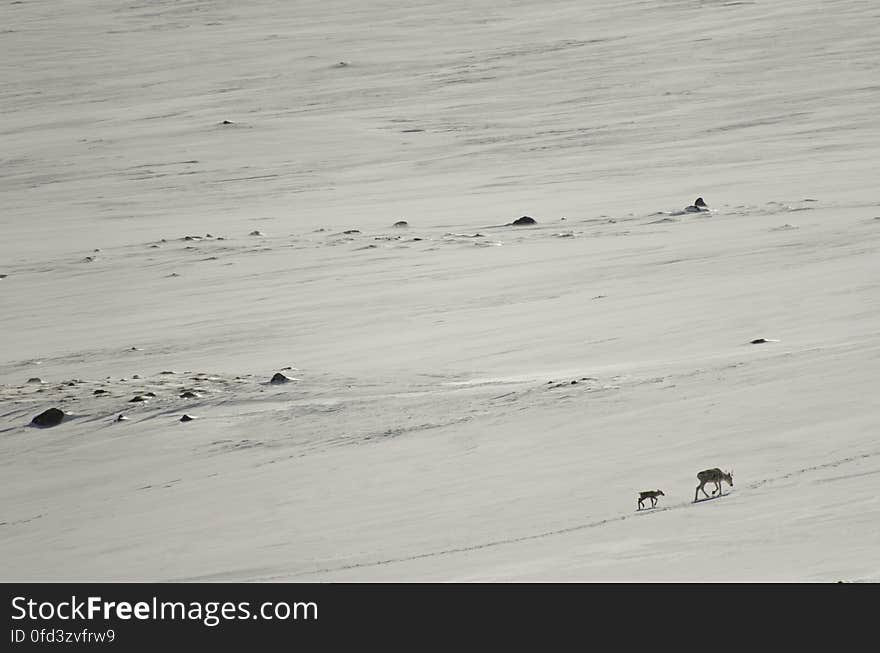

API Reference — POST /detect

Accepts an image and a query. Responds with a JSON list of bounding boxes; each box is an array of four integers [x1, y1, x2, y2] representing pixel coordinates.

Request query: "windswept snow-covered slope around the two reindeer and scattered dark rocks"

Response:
[[0, 0, 880, 581]]
